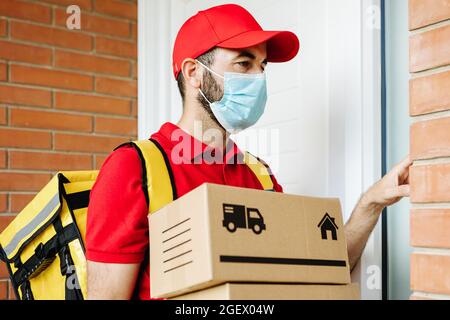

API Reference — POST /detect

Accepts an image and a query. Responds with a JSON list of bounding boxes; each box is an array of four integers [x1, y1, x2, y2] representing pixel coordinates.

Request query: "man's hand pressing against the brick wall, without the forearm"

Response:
[[361, 156, 412, 212]]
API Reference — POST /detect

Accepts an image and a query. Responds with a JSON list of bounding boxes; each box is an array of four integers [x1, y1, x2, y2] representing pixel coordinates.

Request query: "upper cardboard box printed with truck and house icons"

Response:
[[149, 184, 350, 298]]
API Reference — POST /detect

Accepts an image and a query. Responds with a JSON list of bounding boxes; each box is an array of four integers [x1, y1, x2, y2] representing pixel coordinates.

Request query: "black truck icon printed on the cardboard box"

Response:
[[222, 203, 266, 234]]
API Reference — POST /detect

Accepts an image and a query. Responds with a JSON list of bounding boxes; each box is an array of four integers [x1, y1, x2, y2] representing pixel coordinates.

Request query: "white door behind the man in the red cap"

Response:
[[139, 0, 381, 299]]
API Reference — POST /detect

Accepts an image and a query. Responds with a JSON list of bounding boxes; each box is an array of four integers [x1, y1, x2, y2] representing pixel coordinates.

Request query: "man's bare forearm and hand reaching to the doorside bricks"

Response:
[[345, 157, 412, 270]]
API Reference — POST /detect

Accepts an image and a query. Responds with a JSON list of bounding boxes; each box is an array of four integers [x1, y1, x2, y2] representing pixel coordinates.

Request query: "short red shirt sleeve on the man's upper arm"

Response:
[[86, 146, 149, 264]]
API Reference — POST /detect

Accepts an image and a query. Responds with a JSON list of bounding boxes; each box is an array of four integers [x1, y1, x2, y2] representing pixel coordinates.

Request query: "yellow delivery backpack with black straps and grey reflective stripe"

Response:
[[0, 140, 273, 300]]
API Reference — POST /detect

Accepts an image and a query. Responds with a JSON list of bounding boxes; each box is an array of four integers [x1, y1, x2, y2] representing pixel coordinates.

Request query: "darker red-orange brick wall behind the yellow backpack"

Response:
[[0, 0, 137, 299]]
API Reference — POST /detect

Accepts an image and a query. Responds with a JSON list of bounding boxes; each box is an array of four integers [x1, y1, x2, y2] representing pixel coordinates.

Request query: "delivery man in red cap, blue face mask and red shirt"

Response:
[[86, 5, 411, 299]]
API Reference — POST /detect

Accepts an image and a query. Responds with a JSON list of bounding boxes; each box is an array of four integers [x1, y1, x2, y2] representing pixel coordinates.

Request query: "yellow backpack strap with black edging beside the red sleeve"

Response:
[[115, 139, 178, 214]]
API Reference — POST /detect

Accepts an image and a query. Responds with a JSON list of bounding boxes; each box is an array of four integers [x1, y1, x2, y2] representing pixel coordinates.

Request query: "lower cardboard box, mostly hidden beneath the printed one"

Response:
[[173, 283, 361, 300]]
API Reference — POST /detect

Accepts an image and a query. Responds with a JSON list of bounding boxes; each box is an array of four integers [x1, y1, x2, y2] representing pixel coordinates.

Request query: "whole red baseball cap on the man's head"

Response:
[[173, 4, 300, 79]]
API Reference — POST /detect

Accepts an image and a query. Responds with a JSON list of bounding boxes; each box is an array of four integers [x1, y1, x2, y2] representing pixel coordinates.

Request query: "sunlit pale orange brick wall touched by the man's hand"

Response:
[[409, 0, 450, 299]]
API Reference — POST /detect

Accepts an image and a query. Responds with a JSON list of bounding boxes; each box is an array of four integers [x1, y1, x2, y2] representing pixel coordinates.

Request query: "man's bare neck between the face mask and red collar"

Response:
[[177, 106, 230, 149]]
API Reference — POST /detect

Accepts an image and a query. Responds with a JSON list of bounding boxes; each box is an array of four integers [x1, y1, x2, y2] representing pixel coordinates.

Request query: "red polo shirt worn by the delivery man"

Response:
[[86, 123, 282, 299]]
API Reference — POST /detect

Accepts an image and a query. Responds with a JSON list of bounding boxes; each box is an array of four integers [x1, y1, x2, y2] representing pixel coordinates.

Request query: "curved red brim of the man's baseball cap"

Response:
[[217, 31, 300, 62]]
